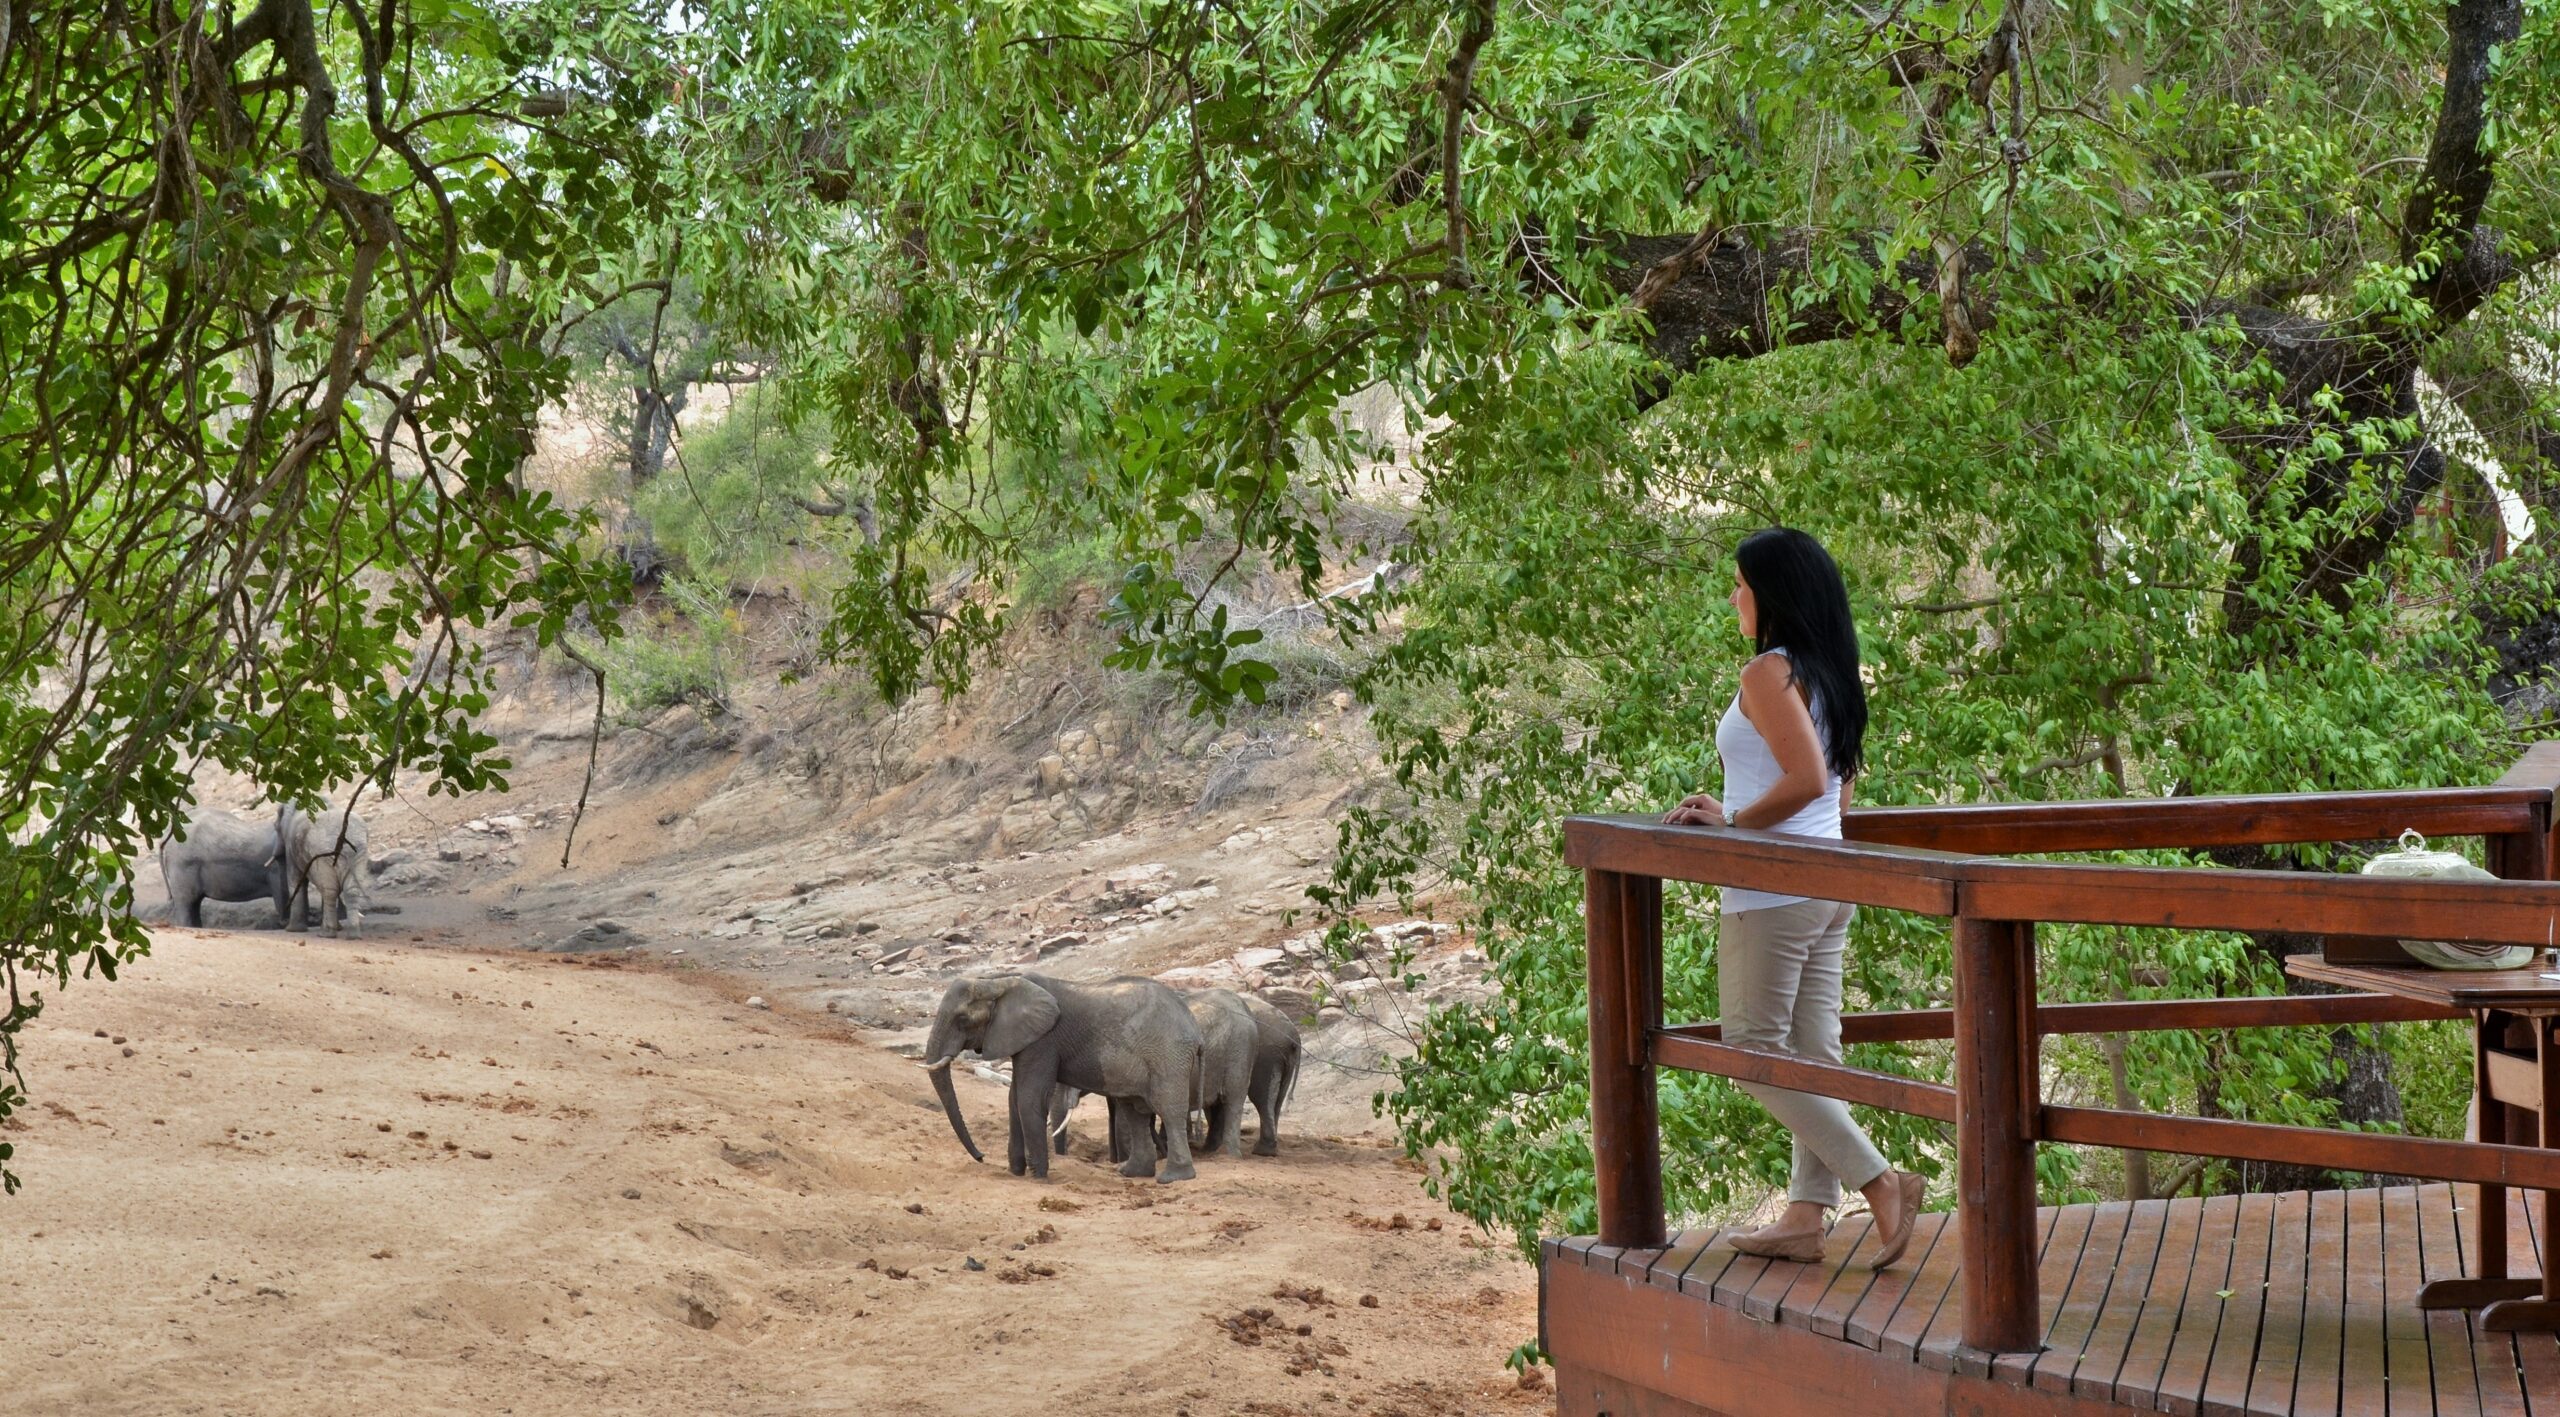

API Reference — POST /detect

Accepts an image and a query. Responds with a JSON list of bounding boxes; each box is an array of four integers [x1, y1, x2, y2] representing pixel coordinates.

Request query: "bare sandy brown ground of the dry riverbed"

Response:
[[0, 928, 1551, 1417]]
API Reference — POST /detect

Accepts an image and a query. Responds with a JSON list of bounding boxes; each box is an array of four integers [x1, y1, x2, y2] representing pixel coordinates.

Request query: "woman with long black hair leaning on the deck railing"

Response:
[[1664, 527, 1925, 1269]]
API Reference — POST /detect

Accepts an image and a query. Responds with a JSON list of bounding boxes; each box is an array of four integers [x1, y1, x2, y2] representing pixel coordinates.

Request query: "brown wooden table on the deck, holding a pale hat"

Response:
[[2284, 954, 2560, 1333]]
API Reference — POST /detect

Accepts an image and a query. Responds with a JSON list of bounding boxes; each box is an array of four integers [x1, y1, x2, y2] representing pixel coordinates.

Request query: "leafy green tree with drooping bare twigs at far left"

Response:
[[0, 0, 660, 1187]]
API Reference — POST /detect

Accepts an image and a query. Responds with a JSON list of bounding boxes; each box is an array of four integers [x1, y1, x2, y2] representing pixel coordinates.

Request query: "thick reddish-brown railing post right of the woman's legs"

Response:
[[1956, 916, 2043, 1353]]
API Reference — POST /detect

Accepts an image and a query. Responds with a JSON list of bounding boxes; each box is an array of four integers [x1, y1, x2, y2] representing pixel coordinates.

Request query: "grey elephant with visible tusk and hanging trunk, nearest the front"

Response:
[[924, 972, 1201, 1182]]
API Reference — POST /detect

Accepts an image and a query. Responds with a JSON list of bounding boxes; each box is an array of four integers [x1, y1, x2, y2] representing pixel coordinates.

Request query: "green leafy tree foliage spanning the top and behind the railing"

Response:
[[0, 0, 2560, 1233]]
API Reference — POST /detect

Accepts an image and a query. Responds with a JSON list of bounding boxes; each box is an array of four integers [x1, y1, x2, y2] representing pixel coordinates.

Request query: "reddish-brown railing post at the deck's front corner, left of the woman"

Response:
[[1582, 870, 1664, 1248]]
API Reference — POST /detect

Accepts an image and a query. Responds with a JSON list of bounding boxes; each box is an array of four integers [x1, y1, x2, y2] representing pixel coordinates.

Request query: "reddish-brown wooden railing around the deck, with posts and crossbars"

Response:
[[1564, 744, 2560, 1350]]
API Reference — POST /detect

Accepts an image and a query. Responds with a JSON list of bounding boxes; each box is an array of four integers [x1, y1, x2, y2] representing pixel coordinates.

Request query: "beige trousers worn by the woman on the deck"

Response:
[[1715, 900, 1887, 1205]]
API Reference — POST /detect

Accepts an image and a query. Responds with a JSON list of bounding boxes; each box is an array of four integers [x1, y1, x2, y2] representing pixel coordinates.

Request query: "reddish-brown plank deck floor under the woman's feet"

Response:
[[1541, 1184, 2560, 1417]]
